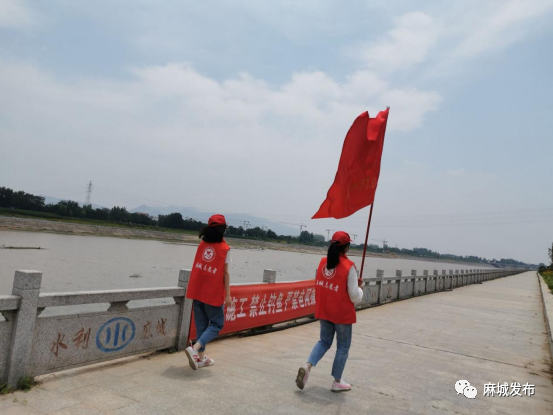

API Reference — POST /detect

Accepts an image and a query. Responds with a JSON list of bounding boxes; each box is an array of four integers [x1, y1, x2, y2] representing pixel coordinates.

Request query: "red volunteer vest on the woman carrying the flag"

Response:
[[315, 255, 357, 324]]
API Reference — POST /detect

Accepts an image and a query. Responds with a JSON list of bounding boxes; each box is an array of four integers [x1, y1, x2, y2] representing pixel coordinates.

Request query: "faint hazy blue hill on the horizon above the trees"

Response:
[[130, 205, 300, 236]]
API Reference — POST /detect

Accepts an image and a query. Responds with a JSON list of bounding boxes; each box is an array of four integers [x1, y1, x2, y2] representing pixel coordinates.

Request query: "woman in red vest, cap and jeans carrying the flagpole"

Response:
[[296, 231, 363, 392]]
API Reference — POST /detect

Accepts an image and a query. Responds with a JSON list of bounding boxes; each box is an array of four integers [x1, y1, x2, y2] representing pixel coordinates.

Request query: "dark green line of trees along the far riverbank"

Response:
[[0, 187, 533, 267]]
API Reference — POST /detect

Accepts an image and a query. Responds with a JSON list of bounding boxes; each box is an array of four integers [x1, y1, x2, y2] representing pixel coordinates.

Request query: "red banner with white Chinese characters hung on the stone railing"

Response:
[[189, 280, 315, 339]]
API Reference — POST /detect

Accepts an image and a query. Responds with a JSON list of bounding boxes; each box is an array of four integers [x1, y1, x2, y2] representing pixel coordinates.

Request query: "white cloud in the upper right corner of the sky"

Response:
[[347, 0, 553, 75]]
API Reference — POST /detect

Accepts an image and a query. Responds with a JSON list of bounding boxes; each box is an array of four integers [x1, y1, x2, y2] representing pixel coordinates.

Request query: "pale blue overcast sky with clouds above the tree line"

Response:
[[0, 0, 553, 263]]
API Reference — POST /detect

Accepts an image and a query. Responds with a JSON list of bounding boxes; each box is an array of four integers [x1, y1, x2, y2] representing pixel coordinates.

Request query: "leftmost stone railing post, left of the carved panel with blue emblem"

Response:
[[7, 271, 42, 387]]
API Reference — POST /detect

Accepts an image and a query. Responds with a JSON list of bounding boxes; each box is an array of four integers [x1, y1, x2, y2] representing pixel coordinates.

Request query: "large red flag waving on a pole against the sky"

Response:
[[312, 109, 389, 219]]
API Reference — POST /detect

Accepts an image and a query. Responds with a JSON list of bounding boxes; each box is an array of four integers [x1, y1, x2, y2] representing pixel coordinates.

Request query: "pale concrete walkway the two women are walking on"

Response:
[[0, 272, 553, 415]]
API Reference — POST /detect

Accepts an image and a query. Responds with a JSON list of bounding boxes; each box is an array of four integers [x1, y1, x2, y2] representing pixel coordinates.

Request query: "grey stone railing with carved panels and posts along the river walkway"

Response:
[[0, 270, 523, 386]]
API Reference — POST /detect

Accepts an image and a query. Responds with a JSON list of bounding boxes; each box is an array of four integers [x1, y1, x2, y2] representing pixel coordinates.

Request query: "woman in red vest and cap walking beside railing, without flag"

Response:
[[184, 215, 231, 370]]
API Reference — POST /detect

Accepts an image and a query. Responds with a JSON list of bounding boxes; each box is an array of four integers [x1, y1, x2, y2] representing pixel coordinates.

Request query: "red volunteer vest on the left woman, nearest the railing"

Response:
[[186, 241, 230, 307]]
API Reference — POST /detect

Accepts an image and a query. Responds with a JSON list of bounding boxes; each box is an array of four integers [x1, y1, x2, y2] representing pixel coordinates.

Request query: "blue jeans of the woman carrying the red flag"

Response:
[[307, 320, 352, 379]]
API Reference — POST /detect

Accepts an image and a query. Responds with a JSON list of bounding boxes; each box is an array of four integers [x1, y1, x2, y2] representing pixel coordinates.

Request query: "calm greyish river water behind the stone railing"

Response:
[[0, 231, 483, 295]]
